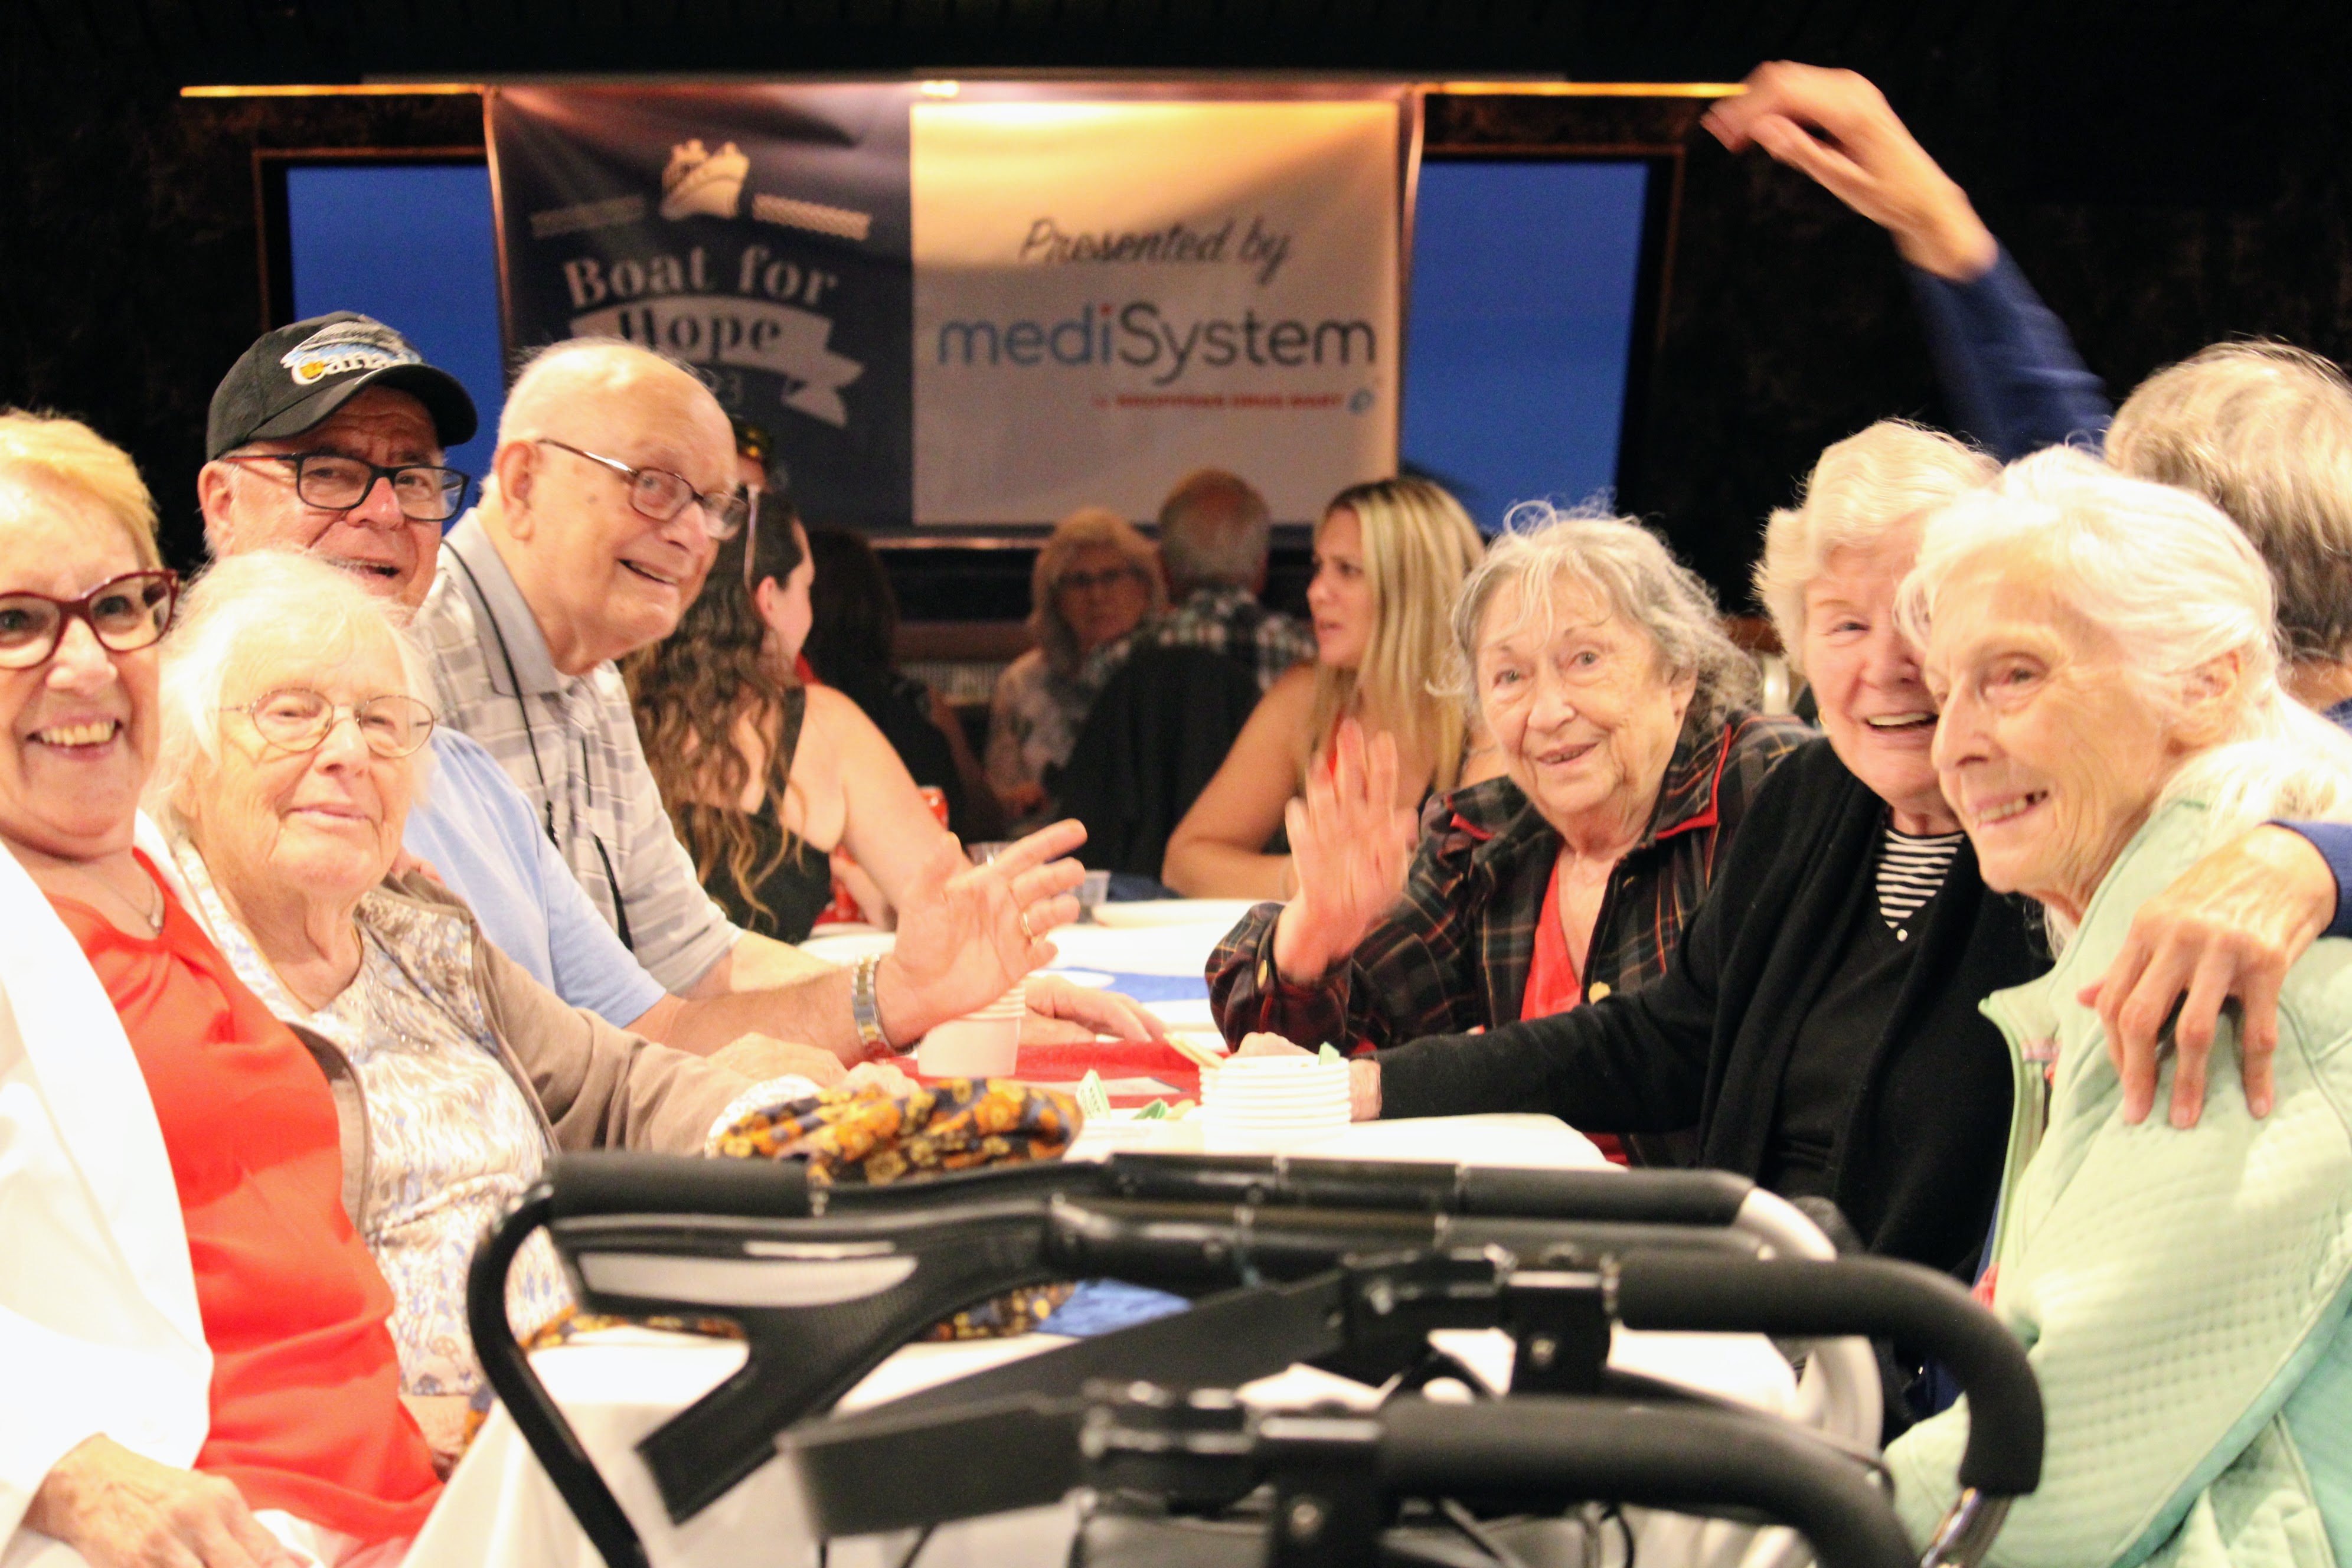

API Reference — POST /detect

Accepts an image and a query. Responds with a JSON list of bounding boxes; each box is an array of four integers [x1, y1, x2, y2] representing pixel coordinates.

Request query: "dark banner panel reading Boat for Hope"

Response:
[[487, 82, 915, 527]]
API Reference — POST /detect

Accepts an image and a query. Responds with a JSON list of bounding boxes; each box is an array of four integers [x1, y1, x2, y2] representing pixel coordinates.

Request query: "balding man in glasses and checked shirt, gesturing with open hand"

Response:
[[416, 338, 1157, 1060]]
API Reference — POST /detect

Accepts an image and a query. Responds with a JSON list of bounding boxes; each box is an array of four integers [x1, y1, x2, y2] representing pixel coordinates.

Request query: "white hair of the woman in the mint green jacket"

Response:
[[1896, 447, 2352, 860]]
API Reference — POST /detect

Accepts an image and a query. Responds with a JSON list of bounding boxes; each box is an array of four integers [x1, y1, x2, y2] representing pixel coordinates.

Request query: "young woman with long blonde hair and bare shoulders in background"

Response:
[[1159, 477, 1484, 898]]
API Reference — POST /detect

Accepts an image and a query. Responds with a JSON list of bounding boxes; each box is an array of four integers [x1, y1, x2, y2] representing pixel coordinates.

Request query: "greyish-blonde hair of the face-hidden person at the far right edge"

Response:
[[2108, 343, 2352, 661]]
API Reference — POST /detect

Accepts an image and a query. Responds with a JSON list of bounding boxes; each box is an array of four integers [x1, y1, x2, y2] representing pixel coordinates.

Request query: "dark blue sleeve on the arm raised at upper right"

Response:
[[1905, 249, 2115, 463]]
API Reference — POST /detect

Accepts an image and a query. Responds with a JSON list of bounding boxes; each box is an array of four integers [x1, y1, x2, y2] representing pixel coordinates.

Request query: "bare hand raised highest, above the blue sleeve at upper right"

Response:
[[1703, 59, 1999, 282]]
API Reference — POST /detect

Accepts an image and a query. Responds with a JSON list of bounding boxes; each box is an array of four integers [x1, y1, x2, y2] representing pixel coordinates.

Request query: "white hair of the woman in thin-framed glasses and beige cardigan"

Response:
[[146, 550, 433, 835]]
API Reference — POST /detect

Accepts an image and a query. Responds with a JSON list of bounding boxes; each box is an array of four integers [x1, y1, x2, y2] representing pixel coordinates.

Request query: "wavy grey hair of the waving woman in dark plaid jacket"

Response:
[[1453, 501, 1757, 724]]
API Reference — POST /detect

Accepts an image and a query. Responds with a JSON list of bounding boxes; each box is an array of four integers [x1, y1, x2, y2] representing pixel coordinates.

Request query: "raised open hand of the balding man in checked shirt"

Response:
[[875, 821, 1087, 1046]]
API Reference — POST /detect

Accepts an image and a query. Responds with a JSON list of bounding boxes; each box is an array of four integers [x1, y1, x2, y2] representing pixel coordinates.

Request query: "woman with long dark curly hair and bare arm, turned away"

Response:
[[623, 491, 946, 943]]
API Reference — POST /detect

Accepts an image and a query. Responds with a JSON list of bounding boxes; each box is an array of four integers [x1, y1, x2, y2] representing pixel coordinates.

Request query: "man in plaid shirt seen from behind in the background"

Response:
[[1080, 468, 1315, 691]]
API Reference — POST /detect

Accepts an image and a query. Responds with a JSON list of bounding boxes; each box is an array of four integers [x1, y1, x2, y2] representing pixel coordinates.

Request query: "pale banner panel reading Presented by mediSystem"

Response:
[[910, 89, 1404, 524]]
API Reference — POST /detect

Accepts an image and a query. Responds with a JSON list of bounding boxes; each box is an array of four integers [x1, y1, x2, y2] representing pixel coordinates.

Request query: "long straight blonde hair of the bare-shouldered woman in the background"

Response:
[[1298, 475, 1484, 792]]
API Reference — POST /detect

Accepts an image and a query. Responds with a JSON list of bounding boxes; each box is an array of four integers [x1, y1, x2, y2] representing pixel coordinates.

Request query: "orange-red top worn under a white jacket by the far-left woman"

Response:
[[50, 858, 440, 1542]]
